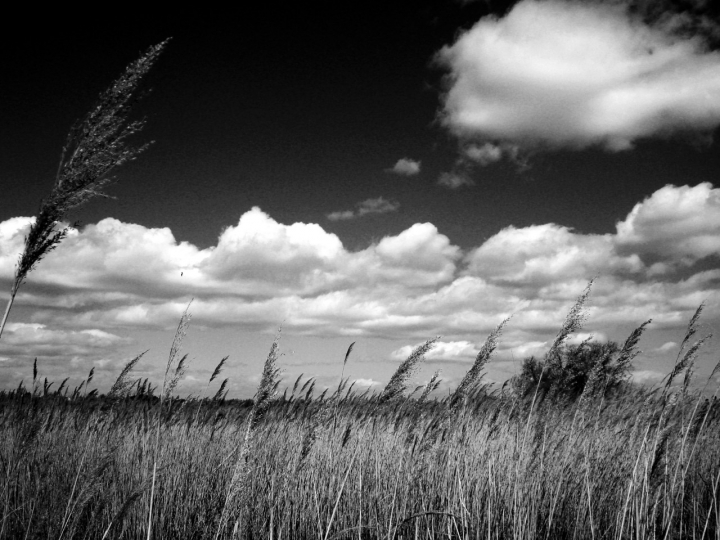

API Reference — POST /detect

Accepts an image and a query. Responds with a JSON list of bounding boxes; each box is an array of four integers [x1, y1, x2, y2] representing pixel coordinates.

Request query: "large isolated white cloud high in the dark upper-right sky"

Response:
[[437, 0, 720, 152]]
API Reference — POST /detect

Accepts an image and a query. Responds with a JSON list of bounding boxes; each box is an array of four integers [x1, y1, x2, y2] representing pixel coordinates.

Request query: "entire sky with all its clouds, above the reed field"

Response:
[[0, 0, 720, 398]]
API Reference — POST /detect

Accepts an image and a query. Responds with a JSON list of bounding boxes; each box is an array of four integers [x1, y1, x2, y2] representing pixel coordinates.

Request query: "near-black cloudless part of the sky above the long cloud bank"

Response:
[[0, 2, 720, 252]]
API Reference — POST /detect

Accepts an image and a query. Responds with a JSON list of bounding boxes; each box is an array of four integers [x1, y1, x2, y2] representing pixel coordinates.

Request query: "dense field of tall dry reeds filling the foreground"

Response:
[[0, 380, 720, 539]]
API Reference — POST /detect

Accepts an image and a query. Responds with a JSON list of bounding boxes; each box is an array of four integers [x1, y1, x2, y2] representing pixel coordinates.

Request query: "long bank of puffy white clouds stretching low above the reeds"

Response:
[[0, 183, 720, 386]]
